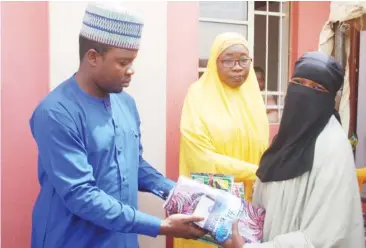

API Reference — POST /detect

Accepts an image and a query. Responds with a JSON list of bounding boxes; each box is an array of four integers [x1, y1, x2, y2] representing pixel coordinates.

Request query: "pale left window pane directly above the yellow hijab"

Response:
[[199, 1, 254, 76]]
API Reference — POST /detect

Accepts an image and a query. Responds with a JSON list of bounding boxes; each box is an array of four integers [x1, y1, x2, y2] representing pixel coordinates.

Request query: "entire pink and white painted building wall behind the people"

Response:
[[0, 1, 329, 248]]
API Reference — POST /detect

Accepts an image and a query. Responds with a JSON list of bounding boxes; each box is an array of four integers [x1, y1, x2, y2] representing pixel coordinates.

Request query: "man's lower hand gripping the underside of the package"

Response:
[[160, 214, 206, 239]]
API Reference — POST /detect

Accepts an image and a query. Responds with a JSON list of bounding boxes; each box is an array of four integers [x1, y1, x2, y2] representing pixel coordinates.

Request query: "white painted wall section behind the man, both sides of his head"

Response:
[[49, 1, 167, 248]]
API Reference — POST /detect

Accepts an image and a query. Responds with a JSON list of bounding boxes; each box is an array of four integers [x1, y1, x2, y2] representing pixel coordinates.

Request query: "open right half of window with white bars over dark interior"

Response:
[[254, 1, 289, 123]]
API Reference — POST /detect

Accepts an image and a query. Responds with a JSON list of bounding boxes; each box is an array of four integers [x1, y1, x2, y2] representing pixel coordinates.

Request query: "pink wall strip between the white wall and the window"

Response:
[[166, 2, 199, 248]]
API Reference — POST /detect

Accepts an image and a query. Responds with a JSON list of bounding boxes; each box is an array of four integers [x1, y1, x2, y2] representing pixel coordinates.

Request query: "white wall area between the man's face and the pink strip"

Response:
[[122, 1, 167, 248]]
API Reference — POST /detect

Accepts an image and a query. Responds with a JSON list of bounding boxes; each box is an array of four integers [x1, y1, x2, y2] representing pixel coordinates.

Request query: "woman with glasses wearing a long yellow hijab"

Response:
[[174, 33, 269, 248]]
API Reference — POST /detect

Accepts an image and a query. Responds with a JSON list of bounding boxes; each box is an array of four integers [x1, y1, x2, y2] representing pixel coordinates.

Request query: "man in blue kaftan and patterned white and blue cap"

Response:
[[30, 4, 203, 248]]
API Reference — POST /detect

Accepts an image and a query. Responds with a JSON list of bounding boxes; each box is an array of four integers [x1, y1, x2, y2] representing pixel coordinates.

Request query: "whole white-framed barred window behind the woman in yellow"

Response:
[[199, 1, 289, 123]]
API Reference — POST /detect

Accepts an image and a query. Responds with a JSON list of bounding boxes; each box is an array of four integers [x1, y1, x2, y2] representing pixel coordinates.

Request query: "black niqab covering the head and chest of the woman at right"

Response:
[[257, 52, 344, 182]]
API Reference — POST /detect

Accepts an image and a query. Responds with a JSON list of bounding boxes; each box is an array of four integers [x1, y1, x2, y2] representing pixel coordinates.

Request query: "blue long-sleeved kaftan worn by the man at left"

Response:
[[30, 76, 174, 248]]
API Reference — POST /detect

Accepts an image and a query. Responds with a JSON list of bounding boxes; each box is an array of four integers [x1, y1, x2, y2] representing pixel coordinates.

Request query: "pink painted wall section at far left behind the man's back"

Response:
[[1, 2, 49, 248]]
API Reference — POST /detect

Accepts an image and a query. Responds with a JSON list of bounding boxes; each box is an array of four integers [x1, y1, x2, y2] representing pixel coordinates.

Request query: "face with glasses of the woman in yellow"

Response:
[[216, 45, 252, 88]]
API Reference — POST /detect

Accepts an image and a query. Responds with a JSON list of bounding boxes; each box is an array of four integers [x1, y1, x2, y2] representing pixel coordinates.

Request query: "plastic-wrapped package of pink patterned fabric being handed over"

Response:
[[164, 176, 265, 245]]
